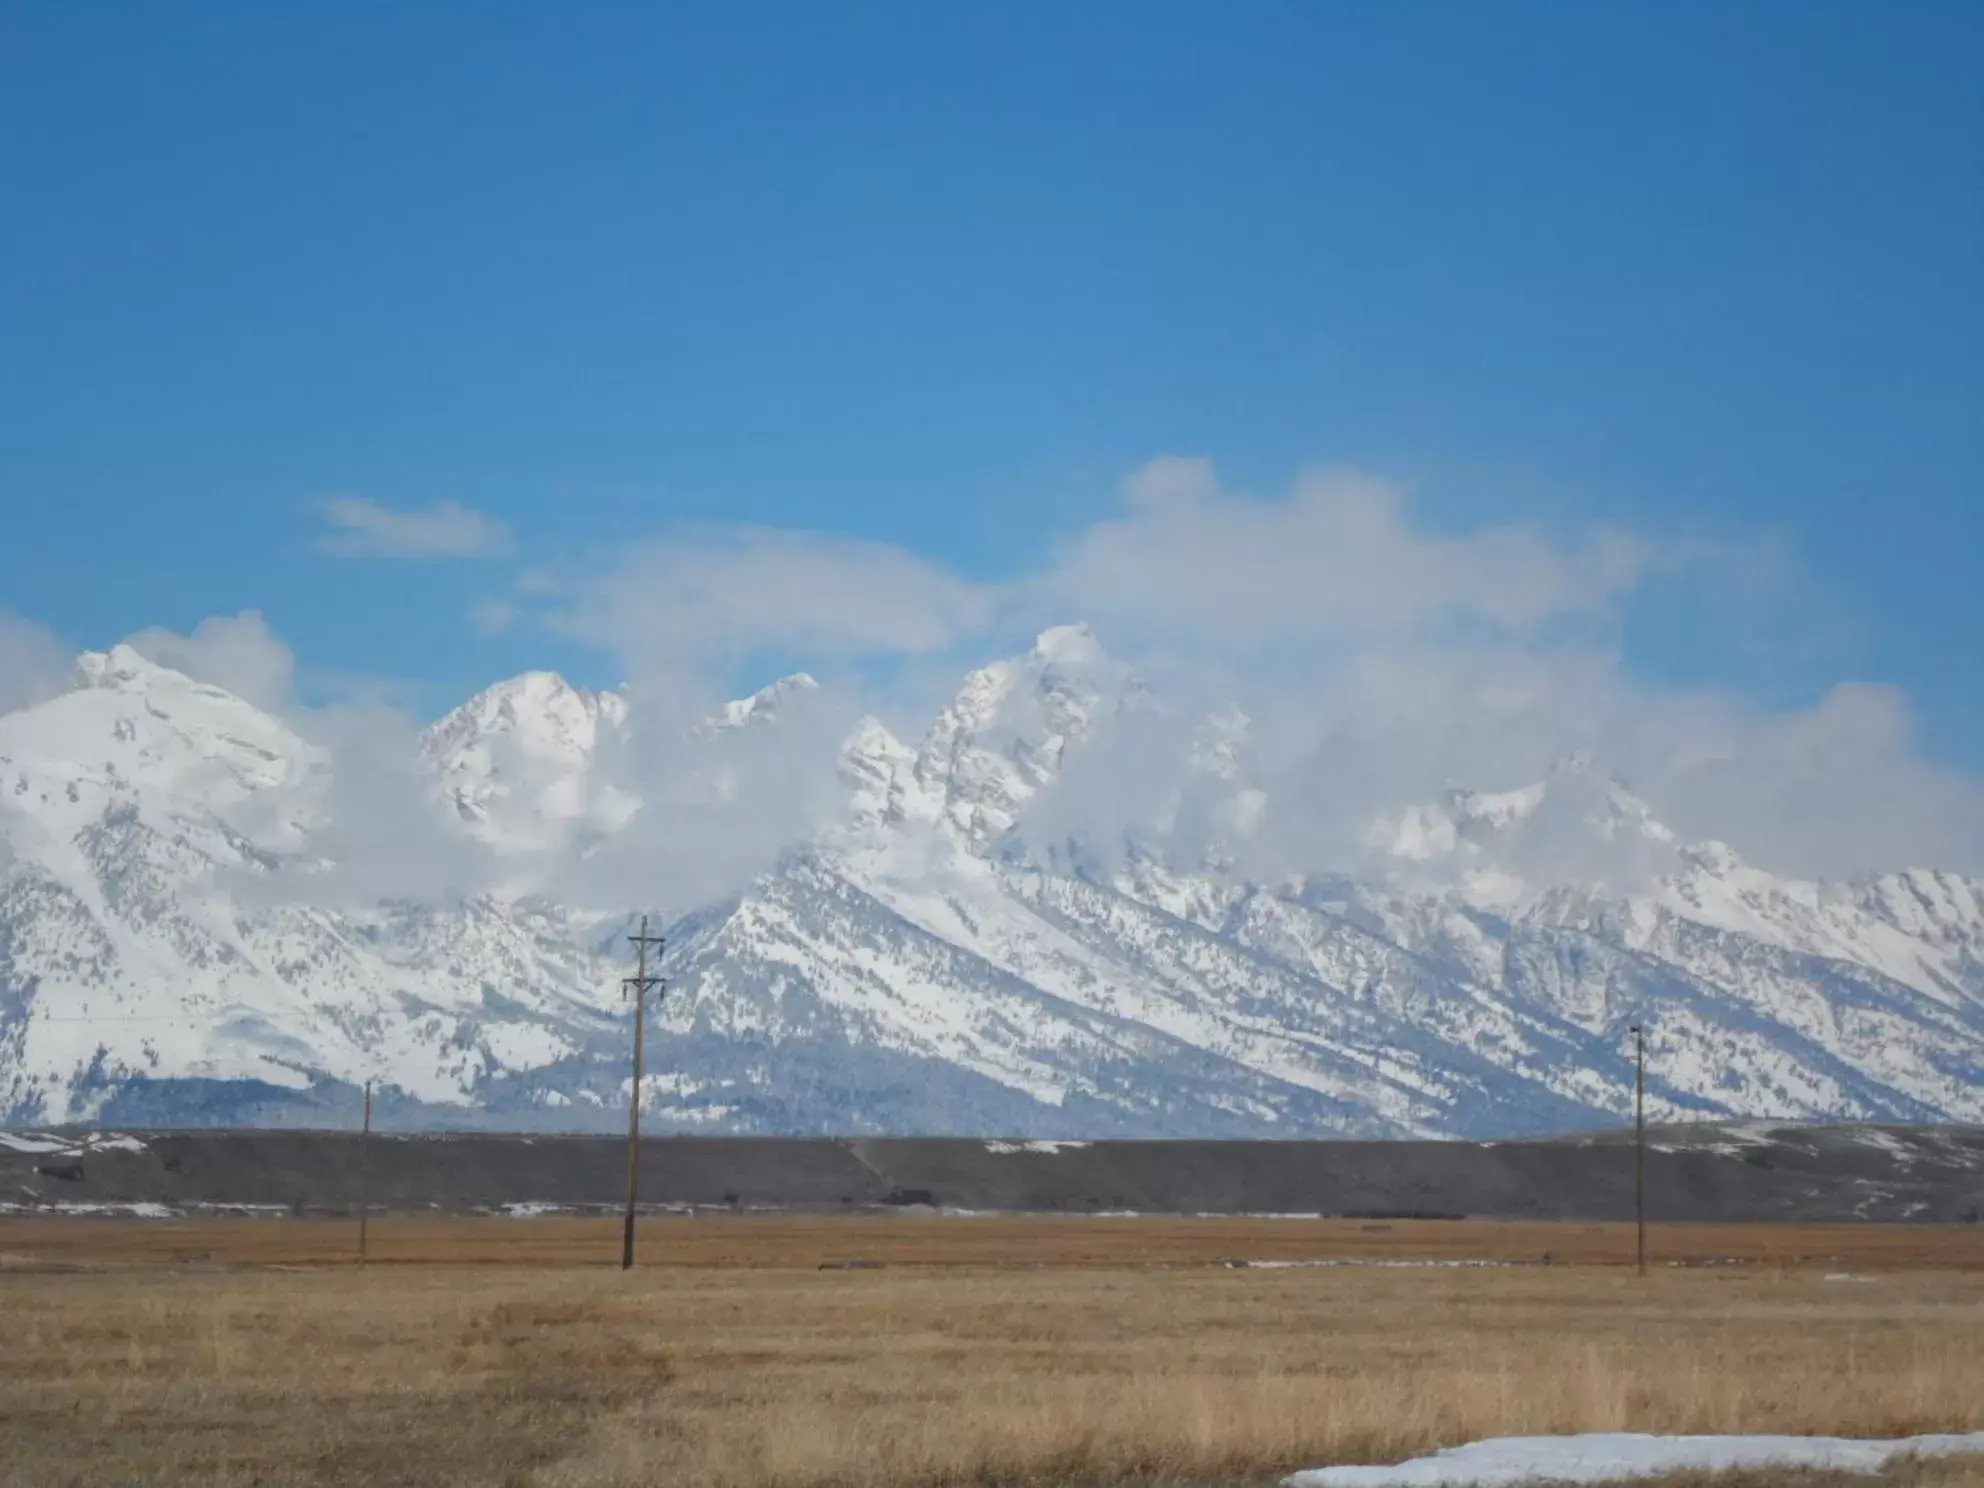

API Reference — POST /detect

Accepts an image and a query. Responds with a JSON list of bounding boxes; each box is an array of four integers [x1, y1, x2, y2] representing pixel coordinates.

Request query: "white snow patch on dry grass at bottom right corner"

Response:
[[1284, 1430, 1984, 1488]]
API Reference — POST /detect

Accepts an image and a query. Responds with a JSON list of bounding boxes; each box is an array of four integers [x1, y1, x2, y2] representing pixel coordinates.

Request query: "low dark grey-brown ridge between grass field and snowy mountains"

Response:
[[0, 1123, 1984, 1224]]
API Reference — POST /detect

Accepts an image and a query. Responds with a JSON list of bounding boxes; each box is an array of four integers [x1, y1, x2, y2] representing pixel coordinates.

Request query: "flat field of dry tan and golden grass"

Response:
[[0, 1216, 1984, 1488]]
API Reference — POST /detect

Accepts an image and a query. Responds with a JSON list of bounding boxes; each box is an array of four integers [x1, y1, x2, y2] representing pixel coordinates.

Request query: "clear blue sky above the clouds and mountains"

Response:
[[0, 0, 1984, 770]]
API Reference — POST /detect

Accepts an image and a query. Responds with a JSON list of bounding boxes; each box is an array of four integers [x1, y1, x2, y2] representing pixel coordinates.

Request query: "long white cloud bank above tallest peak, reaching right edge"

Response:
[[503, 456, 1984, 873]]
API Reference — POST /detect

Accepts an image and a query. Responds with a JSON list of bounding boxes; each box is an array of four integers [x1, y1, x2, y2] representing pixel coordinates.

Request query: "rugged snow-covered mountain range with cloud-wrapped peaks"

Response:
[[0, 627, 1984, 1137]]
